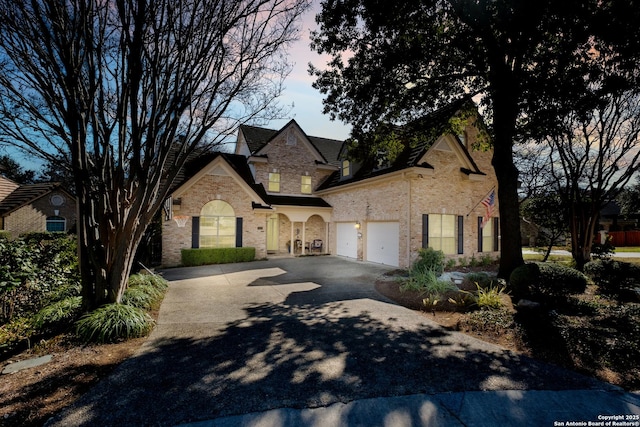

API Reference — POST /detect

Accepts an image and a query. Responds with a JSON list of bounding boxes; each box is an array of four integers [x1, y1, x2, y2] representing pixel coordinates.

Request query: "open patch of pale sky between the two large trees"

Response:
[[264, 0, 351, 140]]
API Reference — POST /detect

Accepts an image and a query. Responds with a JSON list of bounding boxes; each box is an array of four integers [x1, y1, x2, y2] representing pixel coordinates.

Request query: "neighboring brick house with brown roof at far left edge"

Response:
[[0, 182, 76, 238]]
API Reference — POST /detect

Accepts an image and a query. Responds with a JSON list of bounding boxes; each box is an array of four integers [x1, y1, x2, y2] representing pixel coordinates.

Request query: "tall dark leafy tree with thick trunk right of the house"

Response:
[[311, 0, 638, 277]]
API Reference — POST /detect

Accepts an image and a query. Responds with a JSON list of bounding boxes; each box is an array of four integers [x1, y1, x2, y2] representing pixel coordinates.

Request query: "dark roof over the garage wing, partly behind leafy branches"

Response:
[[317, 98, 484, 191]]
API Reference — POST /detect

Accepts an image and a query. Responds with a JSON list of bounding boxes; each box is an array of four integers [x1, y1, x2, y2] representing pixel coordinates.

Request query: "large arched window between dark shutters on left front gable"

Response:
[[200, 200, 236, 248]]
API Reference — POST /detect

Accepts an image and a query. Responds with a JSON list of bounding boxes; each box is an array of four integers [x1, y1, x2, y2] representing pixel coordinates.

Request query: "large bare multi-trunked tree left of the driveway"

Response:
[[0, 0, 308, 310]]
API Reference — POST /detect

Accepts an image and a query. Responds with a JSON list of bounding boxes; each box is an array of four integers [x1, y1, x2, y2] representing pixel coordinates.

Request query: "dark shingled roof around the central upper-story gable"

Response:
[[240, 120, 343, 166]]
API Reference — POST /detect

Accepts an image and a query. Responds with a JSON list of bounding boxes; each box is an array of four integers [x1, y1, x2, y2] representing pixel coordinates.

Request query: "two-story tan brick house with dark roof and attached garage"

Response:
[[163, 100, 499, 267]]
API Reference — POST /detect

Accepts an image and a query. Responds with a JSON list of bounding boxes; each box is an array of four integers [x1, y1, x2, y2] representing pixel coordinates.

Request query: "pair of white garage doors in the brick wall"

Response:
[[336, 221, 400, 267]]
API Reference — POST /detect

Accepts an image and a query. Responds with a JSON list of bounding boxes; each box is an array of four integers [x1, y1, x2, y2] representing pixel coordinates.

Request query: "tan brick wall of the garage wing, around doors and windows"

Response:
[[323, 131, 498, 267]]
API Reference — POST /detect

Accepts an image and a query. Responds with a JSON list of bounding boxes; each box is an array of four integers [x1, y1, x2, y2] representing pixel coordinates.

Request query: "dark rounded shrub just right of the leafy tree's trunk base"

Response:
[[509, 262, 588, 299]]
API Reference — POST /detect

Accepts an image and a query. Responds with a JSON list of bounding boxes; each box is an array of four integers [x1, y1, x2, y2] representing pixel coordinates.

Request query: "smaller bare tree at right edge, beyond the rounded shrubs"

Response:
[[540, 90, 640, 269]]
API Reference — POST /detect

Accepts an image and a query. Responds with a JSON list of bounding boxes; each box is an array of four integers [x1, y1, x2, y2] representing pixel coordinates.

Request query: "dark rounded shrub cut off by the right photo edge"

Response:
[[584, 259, 640, 297]]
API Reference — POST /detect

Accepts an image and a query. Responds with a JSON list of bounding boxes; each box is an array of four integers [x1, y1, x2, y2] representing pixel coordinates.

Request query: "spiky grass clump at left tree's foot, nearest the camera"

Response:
[[76, 304, 155, 343]]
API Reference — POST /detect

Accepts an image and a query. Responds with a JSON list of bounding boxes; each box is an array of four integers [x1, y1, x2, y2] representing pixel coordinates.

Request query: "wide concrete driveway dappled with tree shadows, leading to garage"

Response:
[[47, 256, 640, 427]]
